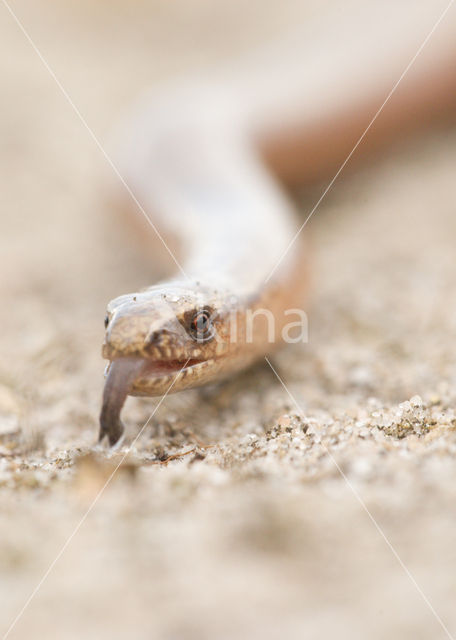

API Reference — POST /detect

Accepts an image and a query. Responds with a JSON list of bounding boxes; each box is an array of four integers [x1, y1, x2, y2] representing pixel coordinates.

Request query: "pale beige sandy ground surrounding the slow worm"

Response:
[[0, 0, 456, 640]]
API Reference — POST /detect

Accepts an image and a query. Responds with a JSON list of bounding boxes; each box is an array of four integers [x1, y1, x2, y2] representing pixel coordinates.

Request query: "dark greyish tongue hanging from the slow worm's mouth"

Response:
[[98, 358, 144, 447]]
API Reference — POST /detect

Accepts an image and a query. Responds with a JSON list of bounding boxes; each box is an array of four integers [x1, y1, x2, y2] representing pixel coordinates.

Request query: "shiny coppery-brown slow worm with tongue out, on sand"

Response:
[[100, 3, 456, 445]]
